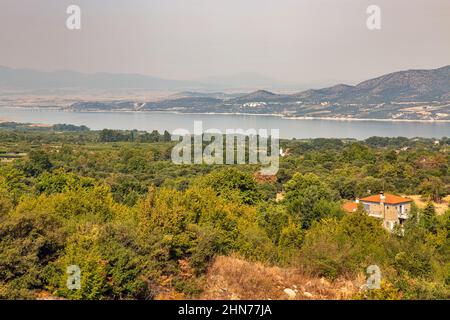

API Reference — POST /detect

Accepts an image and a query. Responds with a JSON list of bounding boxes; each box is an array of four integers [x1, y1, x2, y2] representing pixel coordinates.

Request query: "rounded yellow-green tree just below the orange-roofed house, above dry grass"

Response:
[[301, 210, 389, 278]]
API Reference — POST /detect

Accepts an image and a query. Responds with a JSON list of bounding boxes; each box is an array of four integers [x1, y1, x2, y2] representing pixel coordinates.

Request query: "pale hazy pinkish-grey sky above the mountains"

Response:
[[0, 0, 450, 85]]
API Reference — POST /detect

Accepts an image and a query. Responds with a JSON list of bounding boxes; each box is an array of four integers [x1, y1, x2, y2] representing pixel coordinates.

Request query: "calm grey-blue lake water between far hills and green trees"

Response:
[[0, 108, 450, 139]]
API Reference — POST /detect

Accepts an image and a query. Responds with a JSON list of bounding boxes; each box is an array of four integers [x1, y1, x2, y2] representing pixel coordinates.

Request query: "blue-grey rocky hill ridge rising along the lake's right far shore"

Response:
[[134, 66, 450, 121]]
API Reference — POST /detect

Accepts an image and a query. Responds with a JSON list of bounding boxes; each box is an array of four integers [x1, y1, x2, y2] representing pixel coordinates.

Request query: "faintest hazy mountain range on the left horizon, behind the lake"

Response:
[[0, 66, 294, 92]]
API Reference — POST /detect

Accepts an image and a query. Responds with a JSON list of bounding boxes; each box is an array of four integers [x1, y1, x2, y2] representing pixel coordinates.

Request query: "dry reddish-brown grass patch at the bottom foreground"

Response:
[[200, 256, 364, 300]]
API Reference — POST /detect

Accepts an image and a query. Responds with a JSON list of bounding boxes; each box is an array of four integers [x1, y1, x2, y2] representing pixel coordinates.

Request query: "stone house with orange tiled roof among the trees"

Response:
[[342, 192, 412, 231]]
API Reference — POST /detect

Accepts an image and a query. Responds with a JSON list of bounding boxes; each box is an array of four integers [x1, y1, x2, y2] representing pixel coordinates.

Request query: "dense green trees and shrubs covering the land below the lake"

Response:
[[0, 127, 450, 299]]
